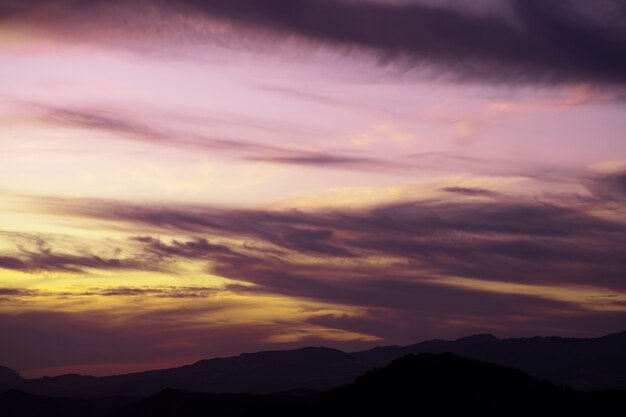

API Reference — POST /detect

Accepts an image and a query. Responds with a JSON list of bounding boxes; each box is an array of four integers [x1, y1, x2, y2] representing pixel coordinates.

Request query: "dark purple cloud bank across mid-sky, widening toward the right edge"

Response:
[[39, 184, 626, 295]]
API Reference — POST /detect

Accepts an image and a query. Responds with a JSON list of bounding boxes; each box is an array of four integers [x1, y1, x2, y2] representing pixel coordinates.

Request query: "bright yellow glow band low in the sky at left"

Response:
[[0, 265, 376, 343]]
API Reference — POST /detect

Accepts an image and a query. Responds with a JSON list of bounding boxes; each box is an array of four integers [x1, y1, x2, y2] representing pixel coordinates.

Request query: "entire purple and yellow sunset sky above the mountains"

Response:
[[0, 0, 626, 377]]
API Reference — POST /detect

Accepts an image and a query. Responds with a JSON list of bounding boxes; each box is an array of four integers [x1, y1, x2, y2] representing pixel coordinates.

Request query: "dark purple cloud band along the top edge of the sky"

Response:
[[0, 0, 626, 85]]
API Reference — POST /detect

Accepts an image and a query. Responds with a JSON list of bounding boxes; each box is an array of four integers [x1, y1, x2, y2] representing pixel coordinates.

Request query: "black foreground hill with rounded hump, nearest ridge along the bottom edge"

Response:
[[109, 354, 624, 417]]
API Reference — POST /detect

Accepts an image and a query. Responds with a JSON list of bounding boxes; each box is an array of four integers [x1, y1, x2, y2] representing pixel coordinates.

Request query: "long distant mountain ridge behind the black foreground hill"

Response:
[[0, 332, 626, 397]]
